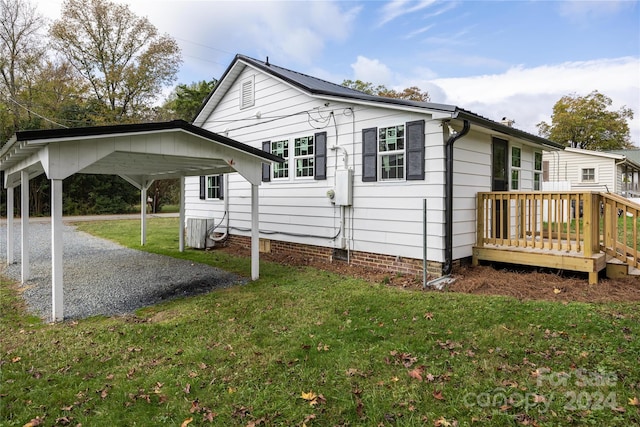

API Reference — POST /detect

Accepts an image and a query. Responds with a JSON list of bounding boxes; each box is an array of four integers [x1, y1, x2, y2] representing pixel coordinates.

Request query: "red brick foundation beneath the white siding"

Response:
[[228, 235, 467, 279]]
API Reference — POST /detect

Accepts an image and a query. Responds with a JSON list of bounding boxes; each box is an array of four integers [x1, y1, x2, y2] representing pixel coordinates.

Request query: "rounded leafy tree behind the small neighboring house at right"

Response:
[[536, 91, 633, 151]]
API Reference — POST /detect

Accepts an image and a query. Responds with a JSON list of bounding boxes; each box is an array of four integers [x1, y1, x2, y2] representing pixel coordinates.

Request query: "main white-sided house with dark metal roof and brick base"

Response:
[[185, 55, 562, 277]]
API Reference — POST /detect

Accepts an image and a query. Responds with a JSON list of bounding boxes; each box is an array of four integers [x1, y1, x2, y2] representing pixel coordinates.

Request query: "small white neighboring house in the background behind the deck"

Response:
[[542, 148, 640, 197]]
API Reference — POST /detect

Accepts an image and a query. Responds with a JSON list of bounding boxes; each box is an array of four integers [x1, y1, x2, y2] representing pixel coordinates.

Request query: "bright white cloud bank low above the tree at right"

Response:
[[431, 57, 640, 145]]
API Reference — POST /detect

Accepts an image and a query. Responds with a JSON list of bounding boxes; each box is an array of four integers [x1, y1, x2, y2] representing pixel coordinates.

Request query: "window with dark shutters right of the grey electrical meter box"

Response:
[[362, 120, 425, 182]]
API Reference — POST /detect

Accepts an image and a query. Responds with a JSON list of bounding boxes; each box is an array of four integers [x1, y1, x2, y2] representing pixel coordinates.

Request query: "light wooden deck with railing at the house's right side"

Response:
[[473, 192, 640, 284]]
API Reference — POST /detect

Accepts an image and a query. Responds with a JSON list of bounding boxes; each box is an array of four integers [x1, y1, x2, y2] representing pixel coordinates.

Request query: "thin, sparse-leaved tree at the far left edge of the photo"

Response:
[[0, 0, 45, 141]]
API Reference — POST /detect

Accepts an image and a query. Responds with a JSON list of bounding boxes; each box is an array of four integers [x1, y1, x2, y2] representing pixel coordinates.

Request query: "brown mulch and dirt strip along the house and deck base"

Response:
[[215, 246, 640, 302]]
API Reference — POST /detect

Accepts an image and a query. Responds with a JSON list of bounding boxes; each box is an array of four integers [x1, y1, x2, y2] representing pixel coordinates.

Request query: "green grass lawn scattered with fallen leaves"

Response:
[[0, 218, 640, 427]]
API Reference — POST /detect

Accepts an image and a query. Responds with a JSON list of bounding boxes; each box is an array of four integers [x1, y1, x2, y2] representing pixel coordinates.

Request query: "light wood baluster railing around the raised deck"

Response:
[[476, 191, 640, 267]]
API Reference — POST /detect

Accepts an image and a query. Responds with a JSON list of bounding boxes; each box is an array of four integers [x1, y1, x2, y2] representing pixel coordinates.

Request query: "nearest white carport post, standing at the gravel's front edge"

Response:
[[51, 179, 64, 322]]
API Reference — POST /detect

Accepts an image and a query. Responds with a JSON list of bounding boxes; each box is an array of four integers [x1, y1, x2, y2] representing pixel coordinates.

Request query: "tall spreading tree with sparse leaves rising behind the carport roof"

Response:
[[50, 0, 181, 123]]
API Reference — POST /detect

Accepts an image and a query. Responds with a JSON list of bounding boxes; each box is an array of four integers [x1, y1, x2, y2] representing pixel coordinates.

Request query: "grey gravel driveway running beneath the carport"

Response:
[[0, 222, 247, 320]]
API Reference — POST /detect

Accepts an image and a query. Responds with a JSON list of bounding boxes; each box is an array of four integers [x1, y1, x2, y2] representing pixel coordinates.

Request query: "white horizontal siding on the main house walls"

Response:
[[186, 66, 552, 262]]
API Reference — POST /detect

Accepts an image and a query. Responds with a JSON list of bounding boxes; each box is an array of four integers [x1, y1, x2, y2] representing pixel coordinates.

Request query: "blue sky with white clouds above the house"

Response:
[[36, 0, 640, 146]]
